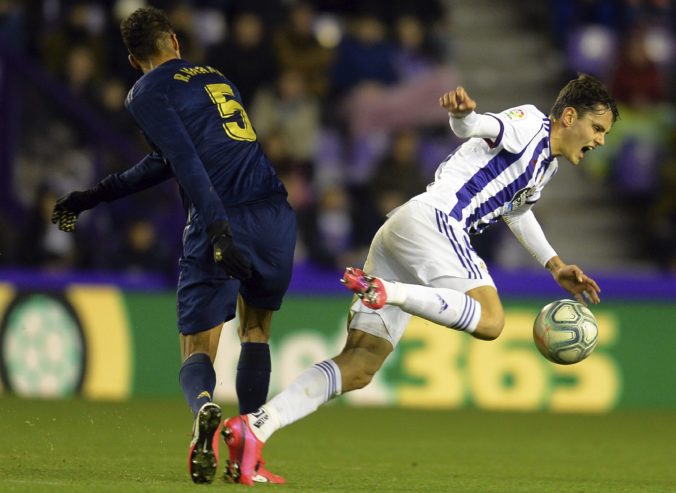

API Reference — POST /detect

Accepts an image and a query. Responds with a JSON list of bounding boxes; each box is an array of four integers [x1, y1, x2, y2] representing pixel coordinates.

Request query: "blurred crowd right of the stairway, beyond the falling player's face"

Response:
[[551, 0, 676, 273]]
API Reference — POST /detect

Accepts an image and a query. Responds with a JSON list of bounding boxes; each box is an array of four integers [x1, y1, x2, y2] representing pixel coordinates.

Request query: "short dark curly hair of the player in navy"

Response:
[[120, 7, 174, 60]]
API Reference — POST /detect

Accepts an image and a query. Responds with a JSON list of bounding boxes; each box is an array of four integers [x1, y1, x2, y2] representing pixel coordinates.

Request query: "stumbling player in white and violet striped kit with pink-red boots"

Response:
[[223, 75, 619, 484]]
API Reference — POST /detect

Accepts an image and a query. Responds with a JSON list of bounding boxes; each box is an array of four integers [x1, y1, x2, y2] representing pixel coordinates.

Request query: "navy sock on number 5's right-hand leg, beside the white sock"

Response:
[[235, 342, 270, 414]]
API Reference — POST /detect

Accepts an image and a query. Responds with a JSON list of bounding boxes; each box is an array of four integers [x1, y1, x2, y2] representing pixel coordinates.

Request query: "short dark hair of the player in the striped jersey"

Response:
[[550, 74, 620, 122]]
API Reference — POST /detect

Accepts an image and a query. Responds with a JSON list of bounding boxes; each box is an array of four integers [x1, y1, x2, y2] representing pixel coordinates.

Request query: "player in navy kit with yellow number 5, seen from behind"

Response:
[[52, 7, 296, 483]]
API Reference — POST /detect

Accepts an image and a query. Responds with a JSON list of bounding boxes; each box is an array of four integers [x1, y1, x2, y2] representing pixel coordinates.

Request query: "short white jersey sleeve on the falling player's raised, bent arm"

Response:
[[486, 105, 544, 153]]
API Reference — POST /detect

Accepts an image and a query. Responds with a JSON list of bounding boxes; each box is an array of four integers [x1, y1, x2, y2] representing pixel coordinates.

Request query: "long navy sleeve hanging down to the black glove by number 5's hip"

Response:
[[128, 91, 227, 226]]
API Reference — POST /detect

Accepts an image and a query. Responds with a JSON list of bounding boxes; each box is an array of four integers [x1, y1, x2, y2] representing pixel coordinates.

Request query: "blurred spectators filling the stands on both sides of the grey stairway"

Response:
[[0, 0, 676, 282]]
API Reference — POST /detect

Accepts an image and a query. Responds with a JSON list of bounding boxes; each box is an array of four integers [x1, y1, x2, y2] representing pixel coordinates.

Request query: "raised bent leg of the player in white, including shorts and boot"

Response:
[[343, 202, 502, 339]]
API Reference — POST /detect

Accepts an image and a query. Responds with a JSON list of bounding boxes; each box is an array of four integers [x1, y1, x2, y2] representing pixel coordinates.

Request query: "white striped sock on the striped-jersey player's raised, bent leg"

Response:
[[381, 279, 481, 333]]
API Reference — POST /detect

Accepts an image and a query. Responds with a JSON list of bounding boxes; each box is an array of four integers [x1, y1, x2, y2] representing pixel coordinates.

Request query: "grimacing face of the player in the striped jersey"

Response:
[[563, 108, 613, 165]]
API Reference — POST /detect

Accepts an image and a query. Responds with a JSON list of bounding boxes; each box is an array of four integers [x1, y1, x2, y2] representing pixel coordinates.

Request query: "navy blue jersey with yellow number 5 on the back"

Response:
[[121, 59, 286, 226]]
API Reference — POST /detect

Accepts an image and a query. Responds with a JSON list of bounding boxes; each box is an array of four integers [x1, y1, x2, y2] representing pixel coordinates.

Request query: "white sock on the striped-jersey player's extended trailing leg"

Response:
[[248, 359, 341, 442]]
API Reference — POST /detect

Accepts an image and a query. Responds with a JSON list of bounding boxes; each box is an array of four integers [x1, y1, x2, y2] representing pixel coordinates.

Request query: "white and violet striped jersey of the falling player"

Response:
[[413, 105, 558, 234]]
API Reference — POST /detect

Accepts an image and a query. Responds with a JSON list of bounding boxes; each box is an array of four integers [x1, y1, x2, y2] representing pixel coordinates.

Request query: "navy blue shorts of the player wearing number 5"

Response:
[[176, 196, 296, 334]]
